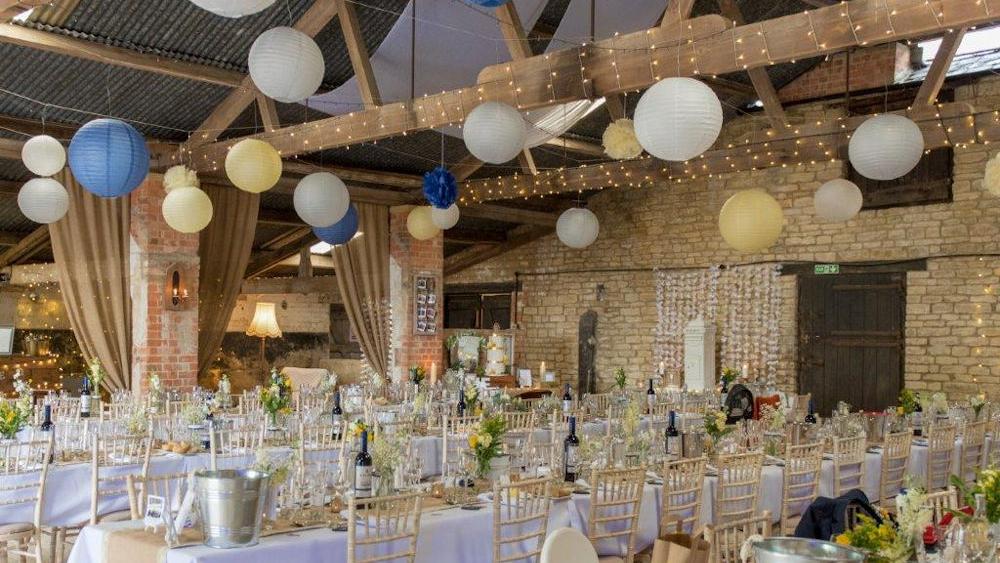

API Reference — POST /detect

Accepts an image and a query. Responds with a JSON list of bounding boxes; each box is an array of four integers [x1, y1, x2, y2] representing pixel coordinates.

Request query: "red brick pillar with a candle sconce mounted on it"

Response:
[[130, 174, 199, 390]]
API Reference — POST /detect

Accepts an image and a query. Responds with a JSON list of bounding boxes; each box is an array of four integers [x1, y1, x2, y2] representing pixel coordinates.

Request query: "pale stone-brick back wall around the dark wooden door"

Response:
[[447, 78, 1000, 396]]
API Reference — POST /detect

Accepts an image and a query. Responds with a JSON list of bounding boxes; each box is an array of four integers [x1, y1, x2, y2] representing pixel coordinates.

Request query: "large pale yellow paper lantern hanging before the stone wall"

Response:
[[719, 188, 785, 252]]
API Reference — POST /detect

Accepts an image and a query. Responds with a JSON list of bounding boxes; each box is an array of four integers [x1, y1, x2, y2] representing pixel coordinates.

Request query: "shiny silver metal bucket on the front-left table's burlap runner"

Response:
[[195, 469, 271, 549]]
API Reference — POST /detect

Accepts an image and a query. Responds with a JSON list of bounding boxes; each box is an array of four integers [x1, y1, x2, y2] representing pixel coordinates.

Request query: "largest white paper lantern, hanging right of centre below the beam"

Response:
[[634, 77, 722, 161]]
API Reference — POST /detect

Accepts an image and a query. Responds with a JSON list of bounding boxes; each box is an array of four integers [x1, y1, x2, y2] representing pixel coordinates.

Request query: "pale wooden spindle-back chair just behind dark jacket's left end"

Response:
[[713, 452, 764, 524]]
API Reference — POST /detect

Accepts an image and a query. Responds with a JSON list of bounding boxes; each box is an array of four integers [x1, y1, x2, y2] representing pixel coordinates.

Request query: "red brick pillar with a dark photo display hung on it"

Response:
[[389, 206, 444, 384]]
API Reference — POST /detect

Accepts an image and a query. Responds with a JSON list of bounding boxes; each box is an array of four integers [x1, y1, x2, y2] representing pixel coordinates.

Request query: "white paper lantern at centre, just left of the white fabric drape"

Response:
[[462, 102, 528, 164]]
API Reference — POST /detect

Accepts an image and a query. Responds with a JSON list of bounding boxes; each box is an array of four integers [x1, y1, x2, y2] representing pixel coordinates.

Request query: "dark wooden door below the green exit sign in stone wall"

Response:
[[798, 272, 906, 416]]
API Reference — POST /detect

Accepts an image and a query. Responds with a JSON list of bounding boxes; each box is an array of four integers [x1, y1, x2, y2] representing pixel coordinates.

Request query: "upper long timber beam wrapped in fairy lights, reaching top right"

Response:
[[186, 0, 1000, 169]]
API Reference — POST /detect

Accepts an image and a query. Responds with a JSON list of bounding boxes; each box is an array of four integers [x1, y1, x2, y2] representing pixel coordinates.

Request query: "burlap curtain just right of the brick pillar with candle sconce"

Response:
[[198, 185, 260, 373]]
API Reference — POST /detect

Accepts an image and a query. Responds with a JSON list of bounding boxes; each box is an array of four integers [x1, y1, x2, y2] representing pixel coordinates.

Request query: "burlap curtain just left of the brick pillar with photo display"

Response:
[[332, 203, 391, 377]]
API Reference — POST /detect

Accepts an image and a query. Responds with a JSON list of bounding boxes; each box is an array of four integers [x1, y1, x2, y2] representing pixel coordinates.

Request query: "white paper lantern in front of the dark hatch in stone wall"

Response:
[[847, 113, 924, 180]]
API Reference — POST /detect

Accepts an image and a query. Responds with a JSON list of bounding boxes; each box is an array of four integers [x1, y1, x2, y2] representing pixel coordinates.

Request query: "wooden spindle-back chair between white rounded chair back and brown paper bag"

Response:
[[587, 467, 646, 563]]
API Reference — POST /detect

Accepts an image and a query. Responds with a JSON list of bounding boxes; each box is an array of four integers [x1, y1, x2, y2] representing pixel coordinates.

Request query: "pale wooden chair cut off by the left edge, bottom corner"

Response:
[[0, 437, 53, 563]]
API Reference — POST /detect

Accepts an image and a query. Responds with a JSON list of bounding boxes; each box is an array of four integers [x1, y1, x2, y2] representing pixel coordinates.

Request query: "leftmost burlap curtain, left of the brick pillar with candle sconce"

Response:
[[49, 168, 132, 391]]
